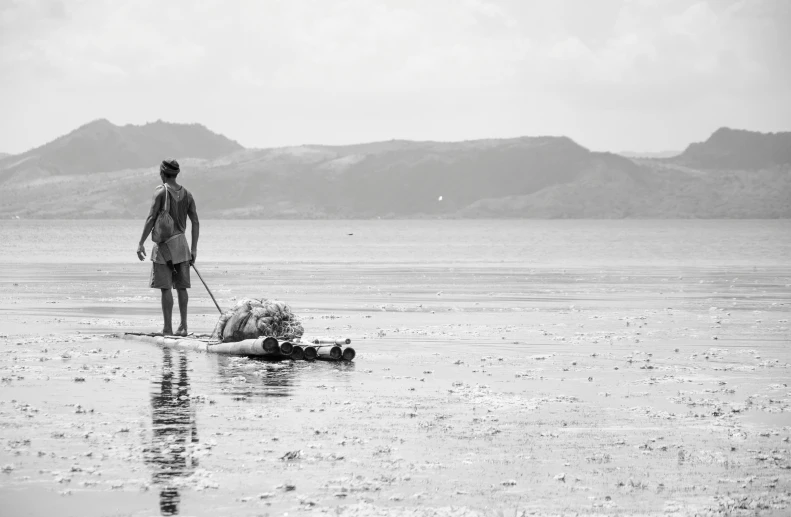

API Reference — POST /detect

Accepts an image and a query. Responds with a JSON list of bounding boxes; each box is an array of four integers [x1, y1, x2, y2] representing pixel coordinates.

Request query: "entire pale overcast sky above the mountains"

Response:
[[0, 0, 791, 153]]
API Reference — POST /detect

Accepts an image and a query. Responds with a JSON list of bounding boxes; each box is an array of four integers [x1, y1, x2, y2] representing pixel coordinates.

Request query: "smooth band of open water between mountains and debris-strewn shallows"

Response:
[[0, 219, 791, 269]]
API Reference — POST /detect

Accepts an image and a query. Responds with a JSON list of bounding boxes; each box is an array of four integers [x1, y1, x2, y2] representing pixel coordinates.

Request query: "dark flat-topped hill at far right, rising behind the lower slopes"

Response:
[[672, 127, 791, 170]]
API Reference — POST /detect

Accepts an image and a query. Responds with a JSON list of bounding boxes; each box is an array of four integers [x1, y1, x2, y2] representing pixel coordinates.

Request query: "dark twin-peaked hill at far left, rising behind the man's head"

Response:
[[0, 119, 242, 183]]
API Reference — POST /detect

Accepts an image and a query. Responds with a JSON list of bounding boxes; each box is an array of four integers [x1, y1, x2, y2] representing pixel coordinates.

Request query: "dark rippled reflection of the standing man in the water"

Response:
[[145, 348, 198, 515]]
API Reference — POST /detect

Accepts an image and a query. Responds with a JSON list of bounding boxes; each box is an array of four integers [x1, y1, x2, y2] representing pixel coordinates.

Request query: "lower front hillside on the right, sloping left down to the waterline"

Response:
[[459, 160, 791, 219]]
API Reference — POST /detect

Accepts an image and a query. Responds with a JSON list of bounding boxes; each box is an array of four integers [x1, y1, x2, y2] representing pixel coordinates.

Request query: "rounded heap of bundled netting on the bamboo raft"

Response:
[[212, 298, 305, 342]]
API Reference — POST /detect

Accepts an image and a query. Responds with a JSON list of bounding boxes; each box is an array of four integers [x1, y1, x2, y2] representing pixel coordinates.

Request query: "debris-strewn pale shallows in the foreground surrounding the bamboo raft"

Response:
[[0, 223, 791, 515]]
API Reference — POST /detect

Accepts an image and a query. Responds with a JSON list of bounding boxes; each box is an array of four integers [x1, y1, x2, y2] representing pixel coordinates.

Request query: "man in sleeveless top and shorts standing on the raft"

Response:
[[137, 160, 200, 336]]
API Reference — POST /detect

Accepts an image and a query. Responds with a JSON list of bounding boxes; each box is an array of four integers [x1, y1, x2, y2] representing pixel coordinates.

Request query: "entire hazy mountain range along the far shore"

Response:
[[0, 120, 791, 218]]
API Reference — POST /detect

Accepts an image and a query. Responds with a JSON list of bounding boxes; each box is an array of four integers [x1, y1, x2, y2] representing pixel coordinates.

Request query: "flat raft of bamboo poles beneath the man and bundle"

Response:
[[120, 332, 357, 361]]
